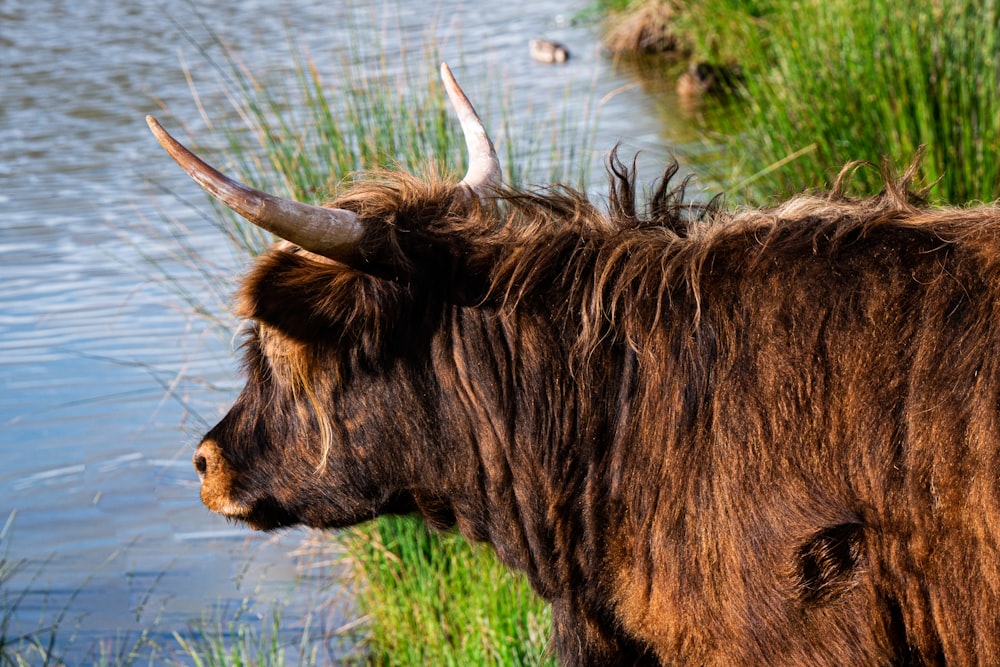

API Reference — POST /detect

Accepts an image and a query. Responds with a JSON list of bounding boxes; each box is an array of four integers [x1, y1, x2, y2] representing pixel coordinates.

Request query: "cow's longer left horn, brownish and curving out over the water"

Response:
[[146, 116, 364, 262]]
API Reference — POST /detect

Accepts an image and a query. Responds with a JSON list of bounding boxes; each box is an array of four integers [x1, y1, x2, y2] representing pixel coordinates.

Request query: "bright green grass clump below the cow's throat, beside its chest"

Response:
[[336, 517, 555, 667]]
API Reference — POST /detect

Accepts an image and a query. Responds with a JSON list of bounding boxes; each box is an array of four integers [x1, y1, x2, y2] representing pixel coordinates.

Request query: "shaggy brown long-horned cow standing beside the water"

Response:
[[151, 64, 1000, 666]]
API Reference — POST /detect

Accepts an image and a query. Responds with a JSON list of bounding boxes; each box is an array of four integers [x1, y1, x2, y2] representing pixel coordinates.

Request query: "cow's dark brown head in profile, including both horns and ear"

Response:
[[147, 65, 501, 529]]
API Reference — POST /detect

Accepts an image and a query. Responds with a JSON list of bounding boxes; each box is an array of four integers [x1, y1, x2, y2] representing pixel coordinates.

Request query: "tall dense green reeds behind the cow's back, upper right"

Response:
[[704, 0, 1000, 202]]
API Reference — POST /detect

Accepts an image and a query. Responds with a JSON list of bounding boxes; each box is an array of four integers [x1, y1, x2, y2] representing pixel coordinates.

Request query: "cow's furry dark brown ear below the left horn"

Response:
[[237, 246, 412, 356]]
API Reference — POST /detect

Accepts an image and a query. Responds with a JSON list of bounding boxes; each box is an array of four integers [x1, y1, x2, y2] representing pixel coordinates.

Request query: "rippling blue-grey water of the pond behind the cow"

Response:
[[0, 0, 704, 662]]
